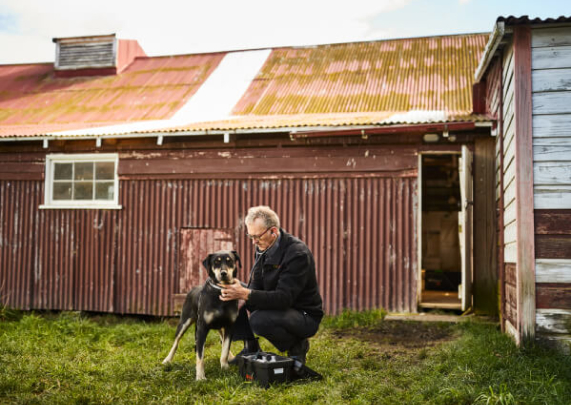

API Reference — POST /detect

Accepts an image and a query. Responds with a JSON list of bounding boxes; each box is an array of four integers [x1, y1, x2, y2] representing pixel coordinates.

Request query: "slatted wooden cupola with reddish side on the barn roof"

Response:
[[53, 34, 147, 77]]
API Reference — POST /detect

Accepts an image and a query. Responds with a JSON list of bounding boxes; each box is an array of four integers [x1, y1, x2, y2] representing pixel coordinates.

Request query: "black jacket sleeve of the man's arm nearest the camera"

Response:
[[248, 252, 310, 310]]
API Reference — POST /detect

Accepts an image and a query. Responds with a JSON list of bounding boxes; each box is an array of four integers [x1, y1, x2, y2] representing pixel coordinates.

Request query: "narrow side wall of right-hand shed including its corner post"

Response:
[[496, 26, 536, 344]]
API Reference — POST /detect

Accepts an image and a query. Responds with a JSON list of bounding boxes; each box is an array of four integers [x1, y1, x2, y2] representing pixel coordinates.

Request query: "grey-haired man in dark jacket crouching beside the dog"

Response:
[[220, 206, 323, 364]]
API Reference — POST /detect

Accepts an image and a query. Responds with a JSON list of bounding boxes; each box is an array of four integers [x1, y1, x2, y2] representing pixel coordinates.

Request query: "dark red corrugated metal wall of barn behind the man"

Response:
[[0, 176, 417, 315]]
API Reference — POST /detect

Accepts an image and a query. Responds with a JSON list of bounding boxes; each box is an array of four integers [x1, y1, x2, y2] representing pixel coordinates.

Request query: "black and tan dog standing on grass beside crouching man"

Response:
[[163, 250, 242, 380]]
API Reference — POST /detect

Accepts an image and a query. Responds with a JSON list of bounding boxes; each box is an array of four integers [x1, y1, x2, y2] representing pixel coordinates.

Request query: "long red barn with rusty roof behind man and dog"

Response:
[[0, 33, 496, 316]]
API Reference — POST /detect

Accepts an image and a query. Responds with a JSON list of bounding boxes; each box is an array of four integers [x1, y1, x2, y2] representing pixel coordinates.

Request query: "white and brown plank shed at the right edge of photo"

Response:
[[476, 16, 571, 352]]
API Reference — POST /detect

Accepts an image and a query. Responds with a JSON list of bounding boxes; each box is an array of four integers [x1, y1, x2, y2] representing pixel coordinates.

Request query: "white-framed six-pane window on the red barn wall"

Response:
[[40, 154, 121, 209]]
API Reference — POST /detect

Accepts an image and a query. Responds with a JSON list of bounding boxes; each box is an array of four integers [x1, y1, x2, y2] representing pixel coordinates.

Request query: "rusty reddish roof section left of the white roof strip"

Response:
[[0, 53, 224, 128]]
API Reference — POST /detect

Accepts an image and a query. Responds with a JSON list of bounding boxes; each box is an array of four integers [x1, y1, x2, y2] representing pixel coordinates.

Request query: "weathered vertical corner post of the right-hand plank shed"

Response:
[[513, 26, 535, 345]]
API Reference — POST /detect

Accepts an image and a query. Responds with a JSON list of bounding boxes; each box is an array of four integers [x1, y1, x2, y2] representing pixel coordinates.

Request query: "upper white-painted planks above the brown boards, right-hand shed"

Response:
[[531, 26, 571, 209]]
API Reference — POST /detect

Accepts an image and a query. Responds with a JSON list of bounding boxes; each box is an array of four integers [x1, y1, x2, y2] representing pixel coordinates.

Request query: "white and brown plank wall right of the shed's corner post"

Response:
[[532, 26, 571, 350]]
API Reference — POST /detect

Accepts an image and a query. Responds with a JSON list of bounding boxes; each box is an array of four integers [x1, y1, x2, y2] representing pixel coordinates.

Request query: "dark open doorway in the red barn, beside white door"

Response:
[[419, 154, 463, 310]]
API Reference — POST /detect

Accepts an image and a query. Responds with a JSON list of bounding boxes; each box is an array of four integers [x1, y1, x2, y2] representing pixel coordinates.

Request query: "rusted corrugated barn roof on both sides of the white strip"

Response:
[[0, 34, 488, 138]]
